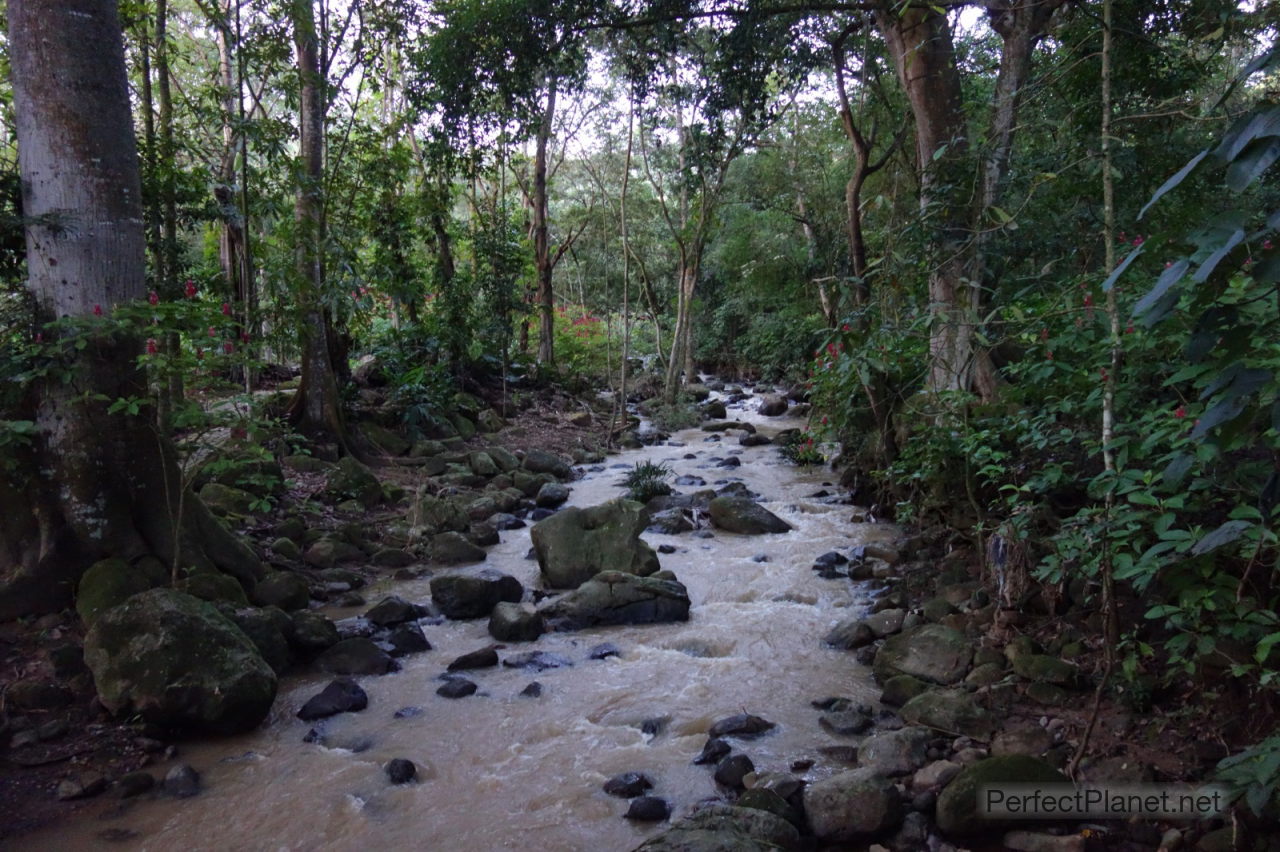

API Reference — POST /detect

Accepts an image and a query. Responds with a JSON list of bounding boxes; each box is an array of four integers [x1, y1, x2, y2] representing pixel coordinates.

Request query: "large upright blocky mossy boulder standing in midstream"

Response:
[[530, 500, 659, 588]]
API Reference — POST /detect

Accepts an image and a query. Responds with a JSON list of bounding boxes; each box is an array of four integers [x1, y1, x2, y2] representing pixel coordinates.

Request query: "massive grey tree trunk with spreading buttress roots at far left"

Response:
[[0, 0, 262, 619]]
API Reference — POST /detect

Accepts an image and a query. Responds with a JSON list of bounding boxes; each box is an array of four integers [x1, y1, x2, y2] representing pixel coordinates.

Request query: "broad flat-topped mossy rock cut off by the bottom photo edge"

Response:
[[635, 805, 800, 852]]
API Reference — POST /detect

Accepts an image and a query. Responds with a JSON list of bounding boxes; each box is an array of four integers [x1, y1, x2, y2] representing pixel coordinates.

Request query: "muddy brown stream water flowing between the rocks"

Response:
[[18, 400, 897, 852]]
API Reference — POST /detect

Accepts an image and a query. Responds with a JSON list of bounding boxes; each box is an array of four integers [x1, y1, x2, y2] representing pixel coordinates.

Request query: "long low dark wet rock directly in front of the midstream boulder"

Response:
[[541, 571, 690, 629]]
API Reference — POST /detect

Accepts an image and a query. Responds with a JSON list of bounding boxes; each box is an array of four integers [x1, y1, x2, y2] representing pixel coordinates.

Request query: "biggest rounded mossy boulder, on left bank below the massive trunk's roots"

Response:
[[84, 588, 276, 733]]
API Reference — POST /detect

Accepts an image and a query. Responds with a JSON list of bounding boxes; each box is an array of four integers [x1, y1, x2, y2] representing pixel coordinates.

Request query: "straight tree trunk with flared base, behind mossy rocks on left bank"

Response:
[[291, 0, 353, 453]]
